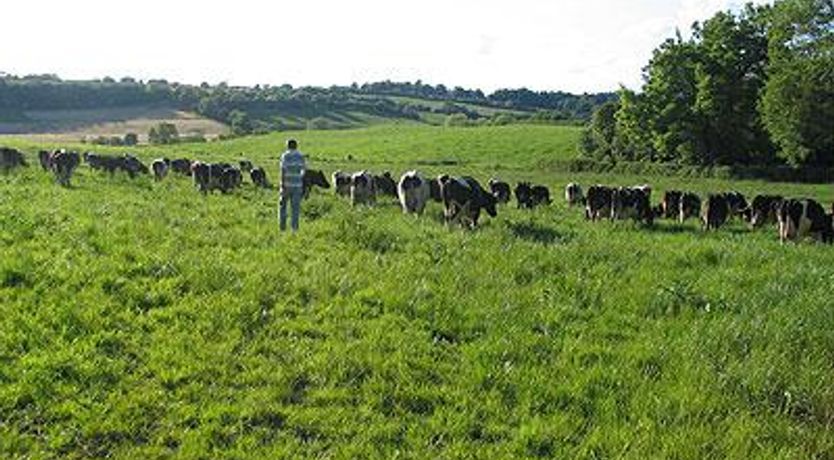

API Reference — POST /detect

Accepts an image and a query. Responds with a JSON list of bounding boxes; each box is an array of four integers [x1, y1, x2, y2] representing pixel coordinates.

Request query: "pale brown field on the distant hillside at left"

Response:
[[0, 106, 229, 143]]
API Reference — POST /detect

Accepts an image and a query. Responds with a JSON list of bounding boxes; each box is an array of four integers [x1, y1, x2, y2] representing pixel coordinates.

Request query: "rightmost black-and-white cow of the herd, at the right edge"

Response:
[[776, 199, 834, 244]]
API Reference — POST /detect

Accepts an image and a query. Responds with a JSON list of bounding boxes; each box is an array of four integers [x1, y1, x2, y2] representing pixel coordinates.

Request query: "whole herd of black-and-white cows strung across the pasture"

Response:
[[0, 147, 834, 243]]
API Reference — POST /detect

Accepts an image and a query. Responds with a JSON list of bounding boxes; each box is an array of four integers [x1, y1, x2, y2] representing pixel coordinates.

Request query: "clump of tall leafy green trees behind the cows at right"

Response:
[[581, 0, 834, 167]]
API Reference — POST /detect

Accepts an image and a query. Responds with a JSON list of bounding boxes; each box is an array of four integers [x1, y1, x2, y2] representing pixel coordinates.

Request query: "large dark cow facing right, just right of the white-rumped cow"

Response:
[[439, 175, 498, 229]]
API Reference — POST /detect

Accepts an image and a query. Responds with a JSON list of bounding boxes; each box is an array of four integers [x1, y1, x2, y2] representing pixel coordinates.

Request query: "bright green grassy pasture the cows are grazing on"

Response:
[[0, 125, 834, 459]]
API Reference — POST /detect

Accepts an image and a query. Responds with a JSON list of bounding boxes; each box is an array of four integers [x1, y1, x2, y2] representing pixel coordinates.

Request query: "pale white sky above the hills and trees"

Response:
[[0, 0, 767, 93]]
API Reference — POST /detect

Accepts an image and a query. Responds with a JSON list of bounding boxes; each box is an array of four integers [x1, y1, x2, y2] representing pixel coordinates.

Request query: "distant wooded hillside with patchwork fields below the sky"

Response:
[[0, 75, 615, 137]]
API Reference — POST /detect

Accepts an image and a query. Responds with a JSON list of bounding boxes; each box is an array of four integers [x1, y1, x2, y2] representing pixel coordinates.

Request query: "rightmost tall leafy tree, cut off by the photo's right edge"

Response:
[[761, 0, 834, 166]]
